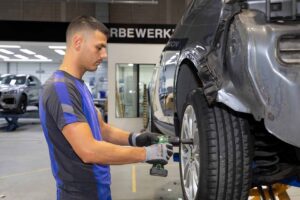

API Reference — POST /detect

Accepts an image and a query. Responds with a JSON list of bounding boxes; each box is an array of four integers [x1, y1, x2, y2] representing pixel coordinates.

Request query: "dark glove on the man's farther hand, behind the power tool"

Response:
[[128, 132, 160, 147]]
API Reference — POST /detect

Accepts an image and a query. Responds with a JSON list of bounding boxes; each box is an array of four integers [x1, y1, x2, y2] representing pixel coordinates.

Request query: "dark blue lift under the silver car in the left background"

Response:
[[0, 110, 39, 131]]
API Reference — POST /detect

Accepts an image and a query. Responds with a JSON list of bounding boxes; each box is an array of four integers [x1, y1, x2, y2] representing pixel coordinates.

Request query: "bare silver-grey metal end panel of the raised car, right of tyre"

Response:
[[217, 11, 300, 147]]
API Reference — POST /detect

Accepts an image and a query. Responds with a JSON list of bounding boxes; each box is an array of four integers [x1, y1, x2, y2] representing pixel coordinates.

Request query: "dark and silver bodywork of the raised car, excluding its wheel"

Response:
[[152, 0, 300, 147]]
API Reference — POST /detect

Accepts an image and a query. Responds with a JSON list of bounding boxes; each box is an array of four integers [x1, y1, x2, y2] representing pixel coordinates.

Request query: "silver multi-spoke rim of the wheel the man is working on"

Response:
[[180, 105, 200, 200]]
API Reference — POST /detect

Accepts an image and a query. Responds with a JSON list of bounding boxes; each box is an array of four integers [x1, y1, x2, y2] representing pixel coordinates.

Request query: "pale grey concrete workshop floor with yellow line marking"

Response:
[[0, 120, 300, 200]]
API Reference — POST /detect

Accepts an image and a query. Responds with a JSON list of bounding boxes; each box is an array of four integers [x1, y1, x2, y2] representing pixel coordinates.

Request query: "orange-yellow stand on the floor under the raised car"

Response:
[[249, 183, 290, 200]]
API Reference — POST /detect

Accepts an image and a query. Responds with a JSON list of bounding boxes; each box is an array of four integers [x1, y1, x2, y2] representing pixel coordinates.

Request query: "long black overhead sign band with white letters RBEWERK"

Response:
[[0, 20, 175, 44]]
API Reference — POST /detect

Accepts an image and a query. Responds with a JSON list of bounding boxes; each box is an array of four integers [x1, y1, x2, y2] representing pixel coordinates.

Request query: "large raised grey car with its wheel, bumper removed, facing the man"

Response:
[[149, 0, 300, 200]]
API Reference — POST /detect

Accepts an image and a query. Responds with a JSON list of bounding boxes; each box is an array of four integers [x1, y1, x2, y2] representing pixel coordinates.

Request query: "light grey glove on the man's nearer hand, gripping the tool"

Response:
[[145, 143, 173, 165]]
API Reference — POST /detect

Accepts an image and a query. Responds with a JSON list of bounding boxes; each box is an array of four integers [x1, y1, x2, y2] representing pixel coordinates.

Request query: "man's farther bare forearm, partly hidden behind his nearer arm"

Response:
[[96, 108, 129, 145]]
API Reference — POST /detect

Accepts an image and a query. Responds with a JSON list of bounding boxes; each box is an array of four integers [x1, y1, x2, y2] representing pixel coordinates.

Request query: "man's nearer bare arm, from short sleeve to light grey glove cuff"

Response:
[[62, 122, 146, 164]]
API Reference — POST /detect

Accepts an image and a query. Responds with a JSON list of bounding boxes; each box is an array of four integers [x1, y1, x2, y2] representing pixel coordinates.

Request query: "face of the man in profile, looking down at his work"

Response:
[[80, 30, 107, 71]]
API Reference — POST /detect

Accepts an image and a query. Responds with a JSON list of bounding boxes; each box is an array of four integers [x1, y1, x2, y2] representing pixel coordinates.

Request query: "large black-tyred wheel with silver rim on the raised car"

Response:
[[179, 89, 252, 200]]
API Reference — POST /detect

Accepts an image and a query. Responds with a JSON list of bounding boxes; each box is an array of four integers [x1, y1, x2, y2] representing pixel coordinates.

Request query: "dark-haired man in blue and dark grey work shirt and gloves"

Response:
[[40, 16, 173, 200]]
